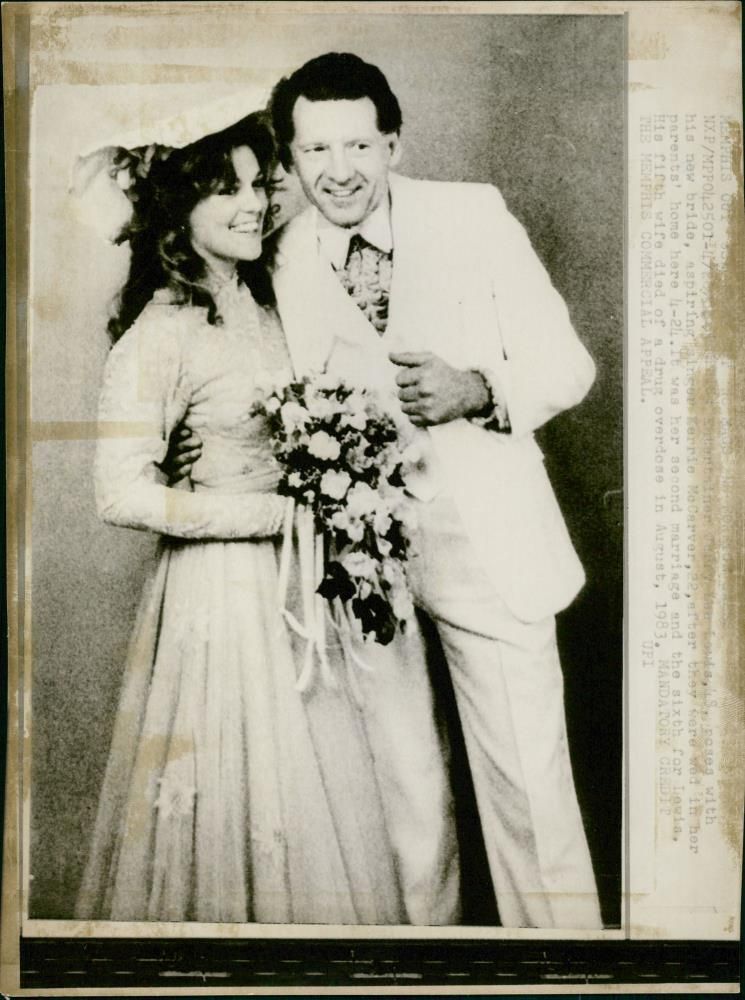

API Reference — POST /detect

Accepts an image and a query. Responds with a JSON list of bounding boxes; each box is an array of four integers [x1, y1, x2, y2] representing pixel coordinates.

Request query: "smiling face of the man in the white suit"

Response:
[[290, 97, 400, 227]]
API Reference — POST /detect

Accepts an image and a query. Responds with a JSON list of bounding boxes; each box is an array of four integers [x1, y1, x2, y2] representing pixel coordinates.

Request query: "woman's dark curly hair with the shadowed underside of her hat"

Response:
[[108, 112, 277, 342]]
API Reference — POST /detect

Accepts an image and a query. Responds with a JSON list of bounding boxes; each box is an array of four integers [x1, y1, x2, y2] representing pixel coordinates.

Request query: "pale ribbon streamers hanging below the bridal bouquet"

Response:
[[278, 497, 372, 700]]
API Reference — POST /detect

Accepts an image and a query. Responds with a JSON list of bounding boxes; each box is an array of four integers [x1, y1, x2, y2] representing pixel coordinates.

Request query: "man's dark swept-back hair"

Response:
[[269, 52, 402, 168]]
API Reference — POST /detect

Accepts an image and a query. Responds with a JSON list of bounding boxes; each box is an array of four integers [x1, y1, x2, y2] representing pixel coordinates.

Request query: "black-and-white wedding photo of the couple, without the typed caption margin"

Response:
[[1, 3, 742, 986]]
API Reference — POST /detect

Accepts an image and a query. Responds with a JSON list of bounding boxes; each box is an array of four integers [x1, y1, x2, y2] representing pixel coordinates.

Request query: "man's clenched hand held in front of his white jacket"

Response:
[[388, 351, 491, 427]]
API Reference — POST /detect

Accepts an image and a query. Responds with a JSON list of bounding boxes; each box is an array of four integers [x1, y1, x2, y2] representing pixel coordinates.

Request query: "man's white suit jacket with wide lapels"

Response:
[[274, 174, 595, 621]]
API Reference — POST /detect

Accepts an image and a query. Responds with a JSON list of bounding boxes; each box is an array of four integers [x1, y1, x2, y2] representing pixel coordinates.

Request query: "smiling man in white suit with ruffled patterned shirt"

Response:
[[264, 53, 601, 928]]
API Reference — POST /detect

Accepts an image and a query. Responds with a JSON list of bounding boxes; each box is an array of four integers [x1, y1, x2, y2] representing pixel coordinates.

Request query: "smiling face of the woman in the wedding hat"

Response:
[[189, 146, 268, 274]]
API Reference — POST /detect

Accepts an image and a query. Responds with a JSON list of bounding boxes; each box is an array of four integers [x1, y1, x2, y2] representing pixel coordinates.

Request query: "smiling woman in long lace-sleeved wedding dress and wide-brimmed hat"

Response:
[[76, 109, 457, 924]]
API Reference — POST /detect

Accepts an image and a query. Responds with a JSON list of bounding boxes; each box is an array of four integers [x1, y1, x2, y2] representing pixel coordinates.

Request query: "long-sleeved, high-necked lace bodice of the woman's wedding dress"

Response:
[[96, 283, 290, 539]]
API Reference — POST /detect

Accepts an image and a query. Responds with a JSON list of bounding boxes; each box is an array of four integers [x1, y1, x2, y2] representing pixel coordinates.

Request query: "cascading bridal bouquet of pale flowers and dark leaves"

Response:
[[251, 373, 414, 645]]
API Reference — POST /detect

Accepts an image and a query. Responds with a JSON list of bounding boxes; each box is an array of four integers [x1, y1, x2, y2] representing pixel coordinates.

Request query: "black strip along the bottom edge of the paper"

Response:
[[21, 938, 740, 994]]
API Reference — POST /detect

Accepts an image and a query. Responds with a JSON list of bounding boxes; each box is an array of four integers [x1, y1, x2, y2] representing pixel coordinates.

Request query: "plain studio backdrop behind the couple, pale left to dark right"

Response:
[[30, 11, 624, 922]]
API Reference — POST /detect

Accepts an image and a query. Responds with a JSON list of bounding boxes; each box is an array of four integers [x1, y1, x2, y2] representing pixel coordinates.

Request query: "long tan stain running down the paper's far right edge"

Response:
[[689, 115, 745, 859]]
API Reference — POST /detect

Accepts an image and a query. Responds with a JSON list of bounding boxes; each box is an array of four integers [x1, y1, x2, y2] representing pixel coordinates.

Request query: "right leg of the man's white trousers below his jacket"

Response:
[[410, 496, 602, 929]]
